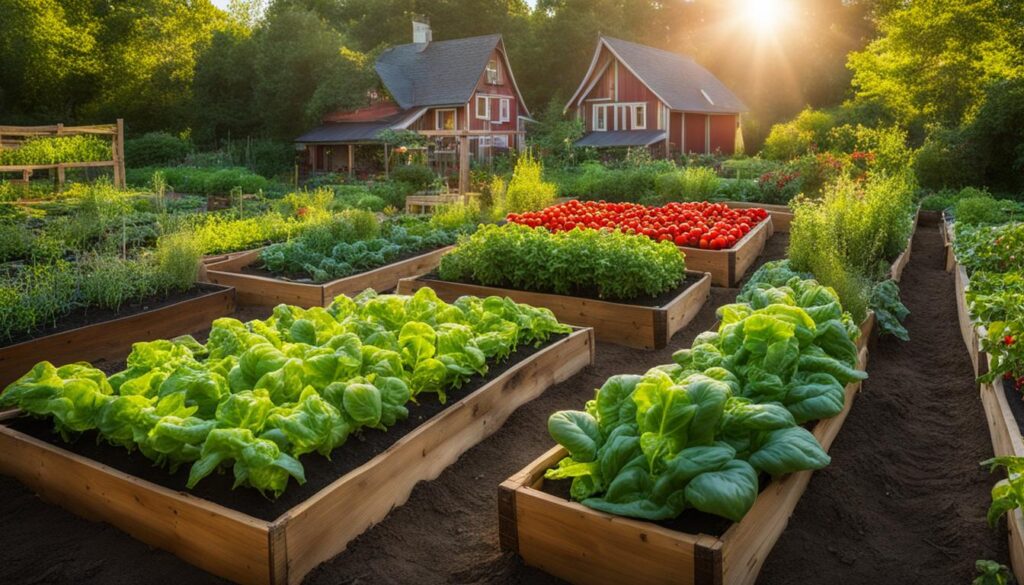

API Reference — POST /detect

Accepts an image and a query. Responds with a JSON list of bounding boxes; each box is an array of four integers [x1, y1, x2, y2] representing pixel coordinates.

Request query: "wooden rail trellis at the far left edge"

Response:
[[0, 118, 125, 190]]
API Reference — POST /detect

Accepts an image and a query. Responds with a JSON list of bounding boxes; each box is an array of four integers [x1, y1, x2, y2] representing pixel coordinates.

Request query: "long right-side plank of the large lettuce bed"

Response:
[[285, 329, 594, 583]]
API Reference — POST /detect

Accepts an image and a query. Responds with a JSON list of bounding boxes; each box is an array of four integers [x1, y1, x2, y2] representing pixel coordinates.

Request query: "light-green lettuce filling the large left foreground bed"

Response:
[[0, 289, 570, 497]]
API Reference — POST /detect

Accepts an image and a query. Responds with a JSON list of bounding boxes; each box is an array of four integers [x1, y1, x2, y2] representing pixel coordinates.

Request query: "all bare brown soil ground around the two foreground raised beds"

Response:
[[0, 229, 1008, 585]]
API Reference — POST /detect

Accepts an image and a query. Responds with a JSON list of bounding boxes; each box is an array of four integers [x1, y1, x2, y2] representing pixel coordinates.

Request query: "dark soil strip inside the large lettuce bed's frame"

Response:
[[8, 335, 566, 521]]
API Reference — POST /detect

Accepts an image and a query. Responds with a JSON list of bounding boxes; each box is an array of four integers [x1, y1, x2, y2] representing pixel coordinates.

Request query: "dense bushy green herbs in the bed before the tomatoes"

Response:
[[438, 224, 686, 300]]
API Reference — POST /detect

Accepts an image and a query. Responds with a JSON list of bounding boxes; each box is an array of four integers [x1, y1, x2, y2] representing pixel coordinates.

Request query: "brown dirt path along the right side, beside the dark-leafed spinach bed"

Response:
[[758, 227, 1009, 585]]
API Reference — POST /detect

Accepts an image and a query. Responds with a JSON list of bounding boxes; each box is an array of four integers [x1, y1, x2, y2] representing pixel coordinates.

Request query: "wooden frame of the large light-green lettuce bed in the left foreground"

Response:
[[0, 329, 594, 585]]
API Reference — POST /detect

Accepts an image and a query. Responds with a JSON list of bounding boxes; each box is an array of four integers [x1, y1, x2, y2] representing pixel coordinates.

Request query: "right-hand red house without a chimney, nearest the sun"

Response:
[[565, 37, 746, 156]]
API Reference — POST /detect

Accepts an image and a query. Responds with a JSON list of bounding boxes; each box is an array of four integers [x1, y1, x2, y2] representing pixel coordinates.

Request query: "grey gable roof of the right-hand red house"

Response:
[[565, 37, 748, 114]]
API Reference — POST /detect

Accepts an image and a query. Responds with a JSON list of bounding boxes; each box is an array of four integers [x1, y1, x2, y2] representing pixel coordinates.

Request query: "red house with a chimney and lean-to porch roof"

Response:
[[295, 22, 529, 182]]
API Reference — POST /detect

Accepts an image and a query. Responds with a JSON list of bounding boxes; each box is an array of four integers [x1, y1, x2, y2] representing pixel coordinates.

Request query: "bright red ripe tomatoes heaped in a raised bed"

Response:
[[508, 200, 768, 250]]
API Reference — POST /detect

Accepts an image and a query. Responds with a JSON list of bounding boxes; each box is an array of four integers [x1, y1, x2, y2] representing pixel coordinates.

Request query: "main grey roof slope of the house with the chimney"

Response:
[[377, 35, 502, 109]]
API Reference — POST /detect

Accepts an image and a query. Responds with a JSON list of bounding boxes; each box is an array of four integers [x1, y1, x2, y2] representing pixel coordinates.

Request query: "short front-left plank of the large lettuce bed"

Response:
[[0, 426, 270, 584]]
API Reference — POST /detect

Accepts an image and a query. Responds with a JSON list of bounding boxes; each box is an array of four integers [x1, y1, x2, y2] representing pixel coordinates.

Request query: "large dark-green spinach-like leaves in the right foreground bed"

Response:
[[545, 276, 866, 521]]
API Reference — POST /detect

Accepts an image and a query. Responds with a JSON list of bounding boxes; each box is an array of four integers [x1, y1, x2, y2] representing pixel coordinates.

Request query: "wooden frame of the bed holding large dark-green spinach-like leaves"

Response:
[[498, 349, 867, 585]]
